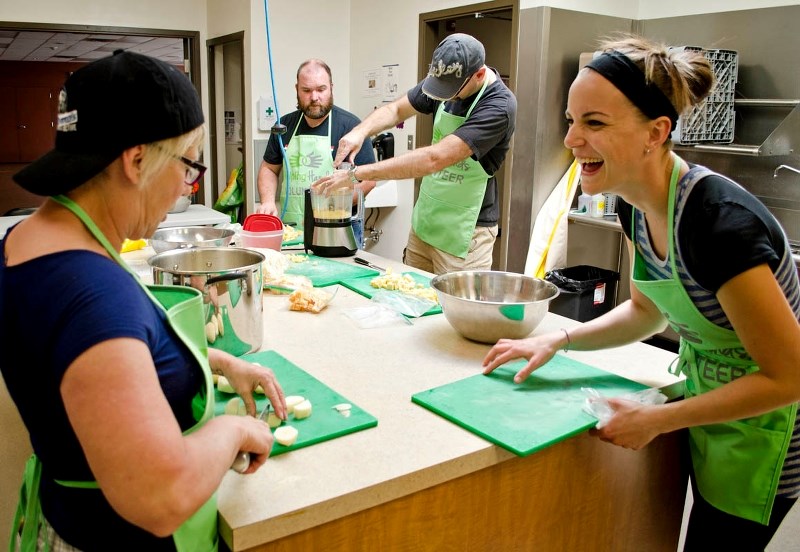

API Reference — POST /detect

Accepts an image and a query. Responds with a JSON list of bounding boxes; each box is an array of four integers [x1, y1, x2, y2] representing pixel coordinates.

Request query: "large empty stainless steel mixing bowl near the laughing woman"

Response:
[[431, 270, 558, 343]]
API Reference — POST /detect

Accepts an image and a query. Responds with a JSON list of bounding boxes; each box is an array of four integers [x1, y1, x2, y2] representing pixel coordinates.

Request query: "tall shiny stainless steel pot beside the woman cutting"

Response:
[[148, 247, 264, 356]]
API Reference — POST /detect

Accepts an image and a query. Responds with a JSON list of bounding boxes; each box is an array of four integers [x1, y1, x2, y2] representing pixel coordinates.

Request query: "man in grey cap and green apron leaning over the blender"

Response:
[[314, 33, 517, 274]]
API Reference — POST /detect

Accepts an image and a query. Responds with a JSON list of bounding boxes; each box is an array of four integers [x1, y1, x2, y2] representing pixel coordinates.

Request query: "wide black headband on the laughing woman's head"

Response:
[[586, 51, 678, 130]]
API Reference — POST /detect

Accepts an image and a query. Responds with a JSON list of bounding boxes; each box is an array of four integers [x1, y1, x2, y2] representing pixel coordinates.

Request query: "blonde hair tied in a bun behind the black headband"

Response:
[[600, 34, 716, 115]]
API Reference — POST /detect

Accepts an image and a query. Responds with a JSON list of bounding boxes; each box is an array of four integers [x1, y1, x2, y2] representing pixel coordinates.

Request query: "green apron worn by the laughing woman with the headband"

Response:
[[632, 156, 797, 525]]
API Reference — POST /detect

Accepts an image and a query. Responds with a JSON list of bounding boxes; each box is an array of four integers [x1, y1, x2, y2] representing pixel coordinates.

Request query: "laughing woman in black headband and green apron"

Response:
[[484, 37, 800, 551]]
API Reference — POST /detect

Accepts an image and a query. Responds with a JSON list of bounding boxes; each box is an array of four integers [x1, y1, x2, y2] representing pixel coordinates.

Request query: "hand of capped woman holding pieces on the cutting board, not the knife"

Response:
[[208, 347, 288, 420]]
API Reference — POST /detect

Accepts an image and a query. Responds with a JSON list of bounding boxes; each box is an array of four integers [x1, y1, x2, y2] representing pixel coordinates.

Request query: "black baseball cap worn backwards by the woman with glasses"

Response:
[[14, 50, 204, 196]]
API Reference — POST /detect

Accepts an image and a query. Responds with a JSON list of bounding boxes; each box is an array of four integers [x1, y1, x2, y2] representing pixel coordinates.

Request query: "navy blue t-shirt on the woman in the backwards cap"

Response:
[[0, 229, 203, 550]]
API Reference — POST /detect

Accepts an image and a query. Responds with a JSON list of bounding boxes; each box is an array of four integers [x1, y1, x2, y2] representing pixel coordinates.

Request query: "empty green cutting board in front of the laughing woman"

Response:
[[411, 354, 646, 456]]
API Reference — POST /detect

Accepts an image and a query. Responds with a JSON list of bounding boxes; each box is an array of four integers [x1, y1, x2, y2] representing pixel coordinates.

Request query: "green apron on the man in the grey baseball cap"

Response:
[[411, 79, 491, 259]]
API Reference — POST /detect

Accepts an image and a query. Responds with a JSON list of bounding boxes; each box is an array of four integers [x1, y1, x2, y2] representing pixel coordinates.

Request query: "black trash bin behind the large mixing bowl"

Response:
[[544, 265, 619, 322]]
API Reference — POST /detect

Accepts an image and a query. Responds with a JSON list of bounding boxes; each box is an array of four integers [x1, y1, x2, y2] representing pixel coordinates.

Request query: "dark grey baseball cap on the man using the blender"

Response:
[[422, 33, 486, 100]]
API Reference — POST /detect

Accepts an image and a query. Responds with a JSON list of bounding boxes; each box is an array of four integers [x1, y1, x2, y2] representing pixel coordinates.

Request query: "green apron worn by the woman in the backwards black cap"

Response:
[[10, 196, 218, 552]]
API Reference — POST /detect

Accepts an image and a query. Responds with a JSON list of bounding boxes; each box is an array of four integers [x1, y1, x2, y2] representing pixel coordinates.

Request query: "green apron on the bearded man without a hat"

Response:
[[280, 111, 333, 229]]
